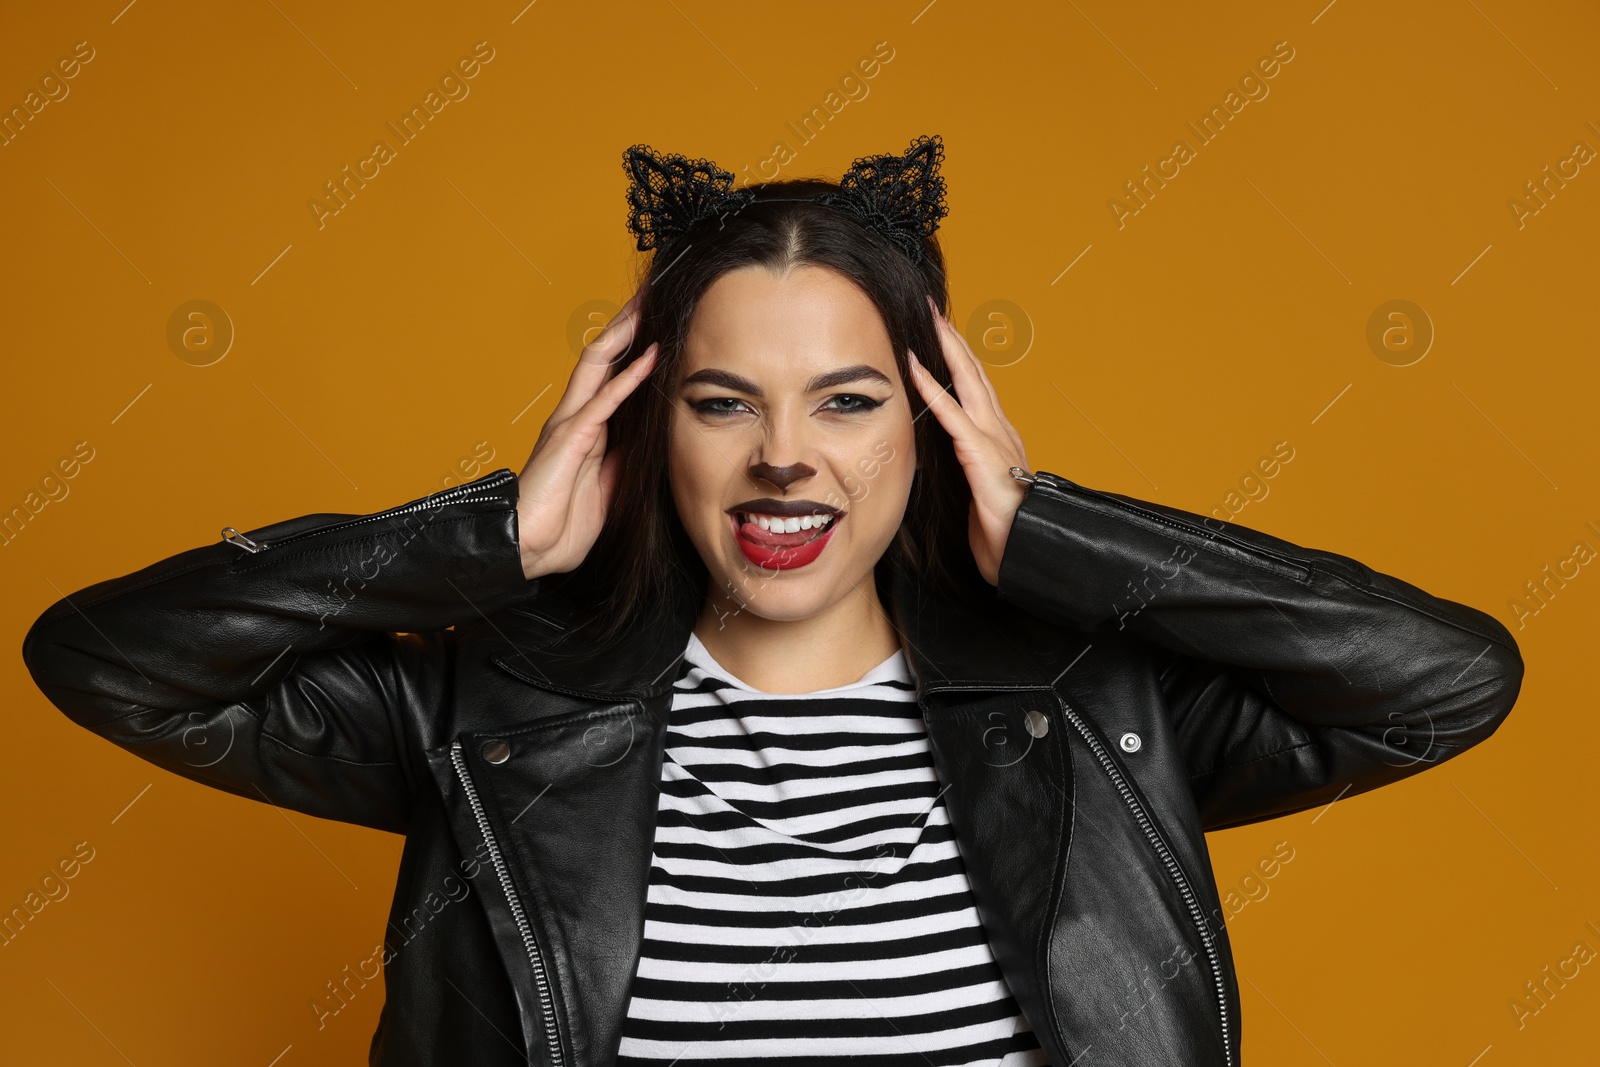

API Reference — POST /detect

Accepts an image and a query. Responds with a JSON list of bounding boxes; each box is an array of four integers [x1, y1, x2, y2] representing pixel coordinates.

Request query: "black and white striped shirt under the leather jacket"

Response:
[[618, 633, 1048, 1067]]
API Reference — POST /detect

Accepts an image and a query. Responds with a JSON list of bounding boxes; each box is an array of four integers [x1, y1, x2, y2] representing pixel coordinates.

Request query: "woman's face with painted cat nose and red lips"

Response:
[[669, 267, 917, 621]]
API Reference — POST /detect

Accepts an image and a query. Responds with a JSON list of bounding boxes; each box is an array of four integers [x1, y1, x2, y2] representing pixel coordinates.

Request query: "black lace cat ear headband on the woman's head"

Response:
[[622, 134, 949, 264]]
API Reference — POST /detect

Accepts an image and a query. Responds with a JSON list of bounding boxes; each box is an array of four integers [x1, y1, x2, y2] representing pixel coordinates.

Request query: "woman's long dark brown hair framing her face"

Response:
[[550, 179, 989, 646]]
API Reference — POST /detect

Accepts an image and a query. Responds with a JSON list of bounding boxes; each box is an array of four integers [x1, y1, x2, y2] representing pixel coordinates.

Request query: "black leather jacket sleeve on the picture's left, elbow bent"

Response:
[[22, 469, 538, 832]]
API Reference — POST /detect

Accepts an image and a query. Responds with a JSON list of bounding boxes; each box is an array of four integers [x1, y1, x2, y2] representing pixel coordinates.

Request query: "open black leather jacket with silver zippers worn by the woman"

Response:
[[24, 470, 1523, 1067]]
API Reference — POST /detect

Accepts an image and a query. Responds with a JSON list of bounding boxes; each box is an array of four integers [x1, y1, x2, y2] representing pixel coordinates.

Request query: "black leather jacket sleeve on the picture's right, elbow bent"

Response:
[[998, 472, 1523, 830]]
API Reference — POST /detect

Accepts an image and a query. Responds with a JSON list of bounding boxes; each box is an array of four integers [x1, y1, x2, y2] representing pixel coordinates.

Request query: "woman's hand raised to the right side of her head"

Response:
[[907, 296, 1032, 585]]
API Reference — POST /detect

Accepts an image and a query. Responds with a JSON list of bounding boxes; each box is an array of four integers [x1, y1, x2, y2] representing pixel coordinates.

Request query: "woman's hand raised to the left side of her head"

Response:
[[517, 290, 658, 581]]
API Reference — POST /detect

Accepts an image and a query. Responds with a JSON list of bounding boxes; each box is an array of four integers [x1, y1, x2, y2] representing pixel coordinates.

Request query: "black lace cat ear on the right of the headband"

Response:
[[818, 134, 950, 262]]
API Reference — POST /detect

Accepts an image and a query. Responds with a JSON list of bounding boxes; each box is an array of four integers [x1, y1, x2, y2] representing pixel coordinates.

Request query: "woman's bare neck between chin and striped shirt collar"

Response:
[[694, 579, 901, 693]]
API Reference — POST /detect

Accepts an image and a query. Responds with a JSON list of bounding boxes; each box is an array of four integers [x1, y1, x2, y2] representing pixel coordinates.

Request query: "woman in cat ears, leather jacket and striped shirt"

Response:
[[24, 138, 1523, 1067]]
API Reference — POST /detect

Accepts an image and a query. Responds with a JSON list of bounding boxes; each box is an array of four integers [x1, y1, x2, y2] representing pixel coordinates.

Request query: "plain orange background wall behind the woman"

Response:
[[0, 0, 1600, 1067]]
